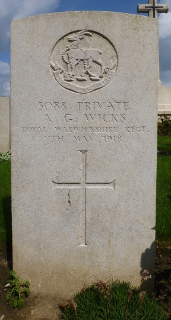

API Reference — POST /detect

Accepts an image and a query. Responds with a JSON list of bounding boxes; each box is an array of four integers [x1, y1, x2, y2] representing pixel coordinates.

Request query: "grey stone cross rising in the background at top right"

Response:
[[137, 0, 169, 18]]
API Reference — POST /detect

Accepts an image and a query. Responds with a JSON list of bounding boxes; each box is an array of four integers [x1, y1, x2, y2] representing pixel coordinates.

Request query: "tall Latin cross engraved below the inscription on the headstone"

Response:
[[52, 150, 115, 247]]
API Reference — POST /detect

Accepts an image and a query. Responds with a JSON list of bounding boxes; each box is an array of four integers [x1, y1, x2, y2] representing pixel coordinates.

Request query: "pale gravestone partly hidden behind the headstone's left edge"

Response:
[[0, 97, 10, 153]]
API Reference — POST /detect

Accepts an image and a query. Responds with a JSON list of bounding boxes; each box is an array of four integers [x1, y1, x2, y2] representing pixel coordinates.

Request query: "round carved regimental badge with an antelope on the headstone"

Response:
[[50, 30, 118, 93]]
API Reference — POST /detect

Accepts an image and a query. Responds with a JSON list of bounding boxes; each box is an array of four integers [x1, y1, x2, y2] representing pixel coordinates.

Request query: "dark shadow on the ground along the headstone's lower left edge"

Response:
[[2, 196, 12, 270]]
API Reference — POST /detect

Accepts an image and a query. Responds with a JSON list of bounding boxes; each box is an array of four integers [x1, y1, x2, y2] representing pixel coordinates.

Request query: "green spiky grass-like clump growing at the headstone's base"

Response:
[[61, 281, 166, 320]]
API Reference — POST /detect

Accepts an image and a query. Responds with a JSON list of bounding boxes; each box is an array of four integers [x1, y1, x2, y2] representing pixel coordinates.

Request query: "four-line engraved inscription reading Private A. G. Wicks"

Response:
[[22, 97, 150, 142]]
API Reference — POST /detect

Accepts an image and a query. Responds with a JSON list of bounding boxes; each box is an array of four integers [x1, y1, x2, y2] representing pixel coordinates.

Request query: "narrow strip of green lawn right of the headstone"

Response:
[[156, 155, 171, 240]]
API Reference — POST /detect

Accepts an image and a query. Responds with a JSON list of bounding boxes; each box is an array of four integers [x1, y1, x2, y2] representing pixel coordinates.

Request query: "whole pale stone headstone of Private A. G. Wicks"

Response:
[[11, 12, 158, 298]]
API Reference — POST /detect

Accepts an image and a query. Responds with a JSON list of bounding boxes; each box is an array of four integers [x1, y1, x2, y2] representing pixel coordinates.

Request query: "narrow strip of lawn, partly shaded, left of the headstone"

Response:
[[0, 160, 11, 242]]
